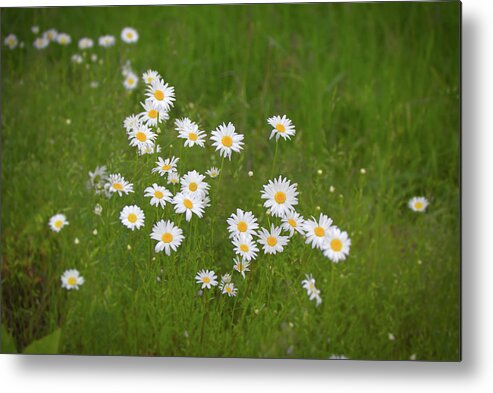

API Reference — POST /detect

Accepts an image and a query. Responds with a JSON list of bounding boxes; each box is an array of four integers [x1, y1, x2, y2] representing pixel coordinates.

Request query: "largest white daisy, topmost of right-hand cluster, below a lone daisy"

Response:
[[261, 176, 299, 217]]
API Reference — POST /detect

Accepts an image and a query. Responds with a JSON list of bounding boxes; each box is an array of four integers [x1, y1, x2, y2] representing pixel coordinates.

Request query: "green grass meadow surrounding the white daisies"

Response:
[[1, 2, 460, 361]]
